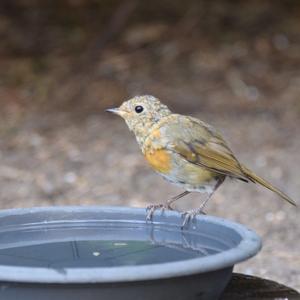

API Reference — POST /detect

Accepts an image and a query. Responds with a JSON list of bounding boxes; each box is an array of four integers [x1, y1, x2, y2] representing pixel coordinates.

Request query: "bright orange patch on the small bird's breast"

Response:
[[145, 149, 171, 174]]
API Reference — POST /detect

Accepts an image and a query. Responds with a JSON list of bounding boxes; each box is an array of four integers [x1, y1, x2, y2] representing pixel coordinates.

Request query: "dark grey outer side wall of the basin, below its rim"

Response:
[[0, 268, 232, 300]]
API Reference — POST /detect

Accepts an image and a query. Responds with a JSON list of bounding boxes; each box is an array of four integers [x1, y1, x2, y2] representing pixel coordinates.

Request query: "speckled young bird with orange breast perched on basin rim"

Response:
[[107, 96, 296, 226]]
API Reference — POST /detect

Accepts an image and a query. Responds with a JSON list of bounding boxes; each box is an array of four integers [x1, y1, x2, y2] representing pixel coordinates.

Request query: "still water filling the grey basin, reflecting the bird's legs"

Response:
[[0, 222, 232, 269]]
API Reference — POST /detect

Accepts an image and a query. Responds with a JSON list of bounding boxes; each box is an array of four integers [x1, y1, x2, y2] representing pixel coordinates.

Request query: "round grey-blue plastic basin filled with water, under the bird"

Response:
[[0, 206, 261, 300]]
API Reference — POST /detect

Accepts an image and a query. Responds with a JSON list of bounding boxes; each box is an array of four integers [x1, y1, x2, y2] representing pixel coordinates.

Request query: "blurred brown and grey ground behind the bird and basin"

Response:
[[0, 0, 300, 289]]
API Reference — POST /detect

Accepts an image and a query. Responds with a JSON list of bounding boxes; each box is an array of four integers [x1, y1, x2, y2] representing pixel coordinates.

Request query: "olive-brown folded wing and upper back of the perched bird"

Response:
[[162, 115, 251, 181]]
